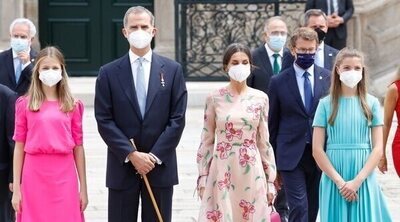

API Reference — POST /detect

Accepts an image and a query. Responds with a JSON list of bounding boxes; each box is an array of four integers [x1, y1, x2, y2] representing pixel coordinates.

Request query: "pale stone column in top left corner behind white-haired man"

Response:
[[0, 0, 23, 50]]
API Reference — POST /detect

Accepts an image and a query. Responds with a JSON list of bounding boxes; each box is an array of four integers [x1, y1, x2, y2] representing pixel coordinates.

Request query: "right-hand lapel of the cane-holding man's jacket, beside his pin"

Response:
[[145, 53, 166, 116]]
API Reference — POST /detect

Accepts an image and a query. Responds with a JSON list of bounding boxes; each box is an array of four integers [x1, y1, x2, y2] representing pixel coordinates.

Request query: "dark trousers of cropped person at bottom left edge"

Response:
[[0, 169, 14, 222]]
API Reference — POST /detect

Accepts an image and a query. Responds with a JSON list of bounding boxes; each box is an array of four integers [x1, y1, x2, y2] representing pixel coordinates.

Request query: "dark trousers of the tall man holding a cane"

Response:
[[108, 175, 173, 222]]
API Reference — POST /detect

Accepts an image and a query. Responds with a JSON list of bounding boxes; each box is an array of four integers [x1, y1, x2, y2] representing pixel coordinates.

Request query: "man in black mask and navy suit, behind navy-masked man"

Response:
[[282, 9, 338, 71]]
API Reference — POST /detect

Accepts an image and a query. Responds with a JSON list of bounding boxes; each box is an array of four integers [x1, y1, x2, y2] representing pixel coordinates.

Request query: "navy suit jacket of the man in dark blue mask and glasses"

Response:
[[268, 65, 330, 170]]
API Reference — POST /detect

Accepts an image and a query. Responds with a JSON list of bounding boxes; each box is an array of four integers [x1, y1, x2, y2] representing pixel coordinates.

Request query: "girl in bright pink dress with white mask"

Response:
[[12, 47, 88, 222]]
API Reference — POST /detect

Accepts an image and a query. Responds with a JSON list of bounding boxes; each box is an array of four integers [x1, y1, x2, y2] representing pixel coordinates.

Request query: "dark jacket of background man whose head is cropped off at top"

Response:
[[305, 0, 354, 39]]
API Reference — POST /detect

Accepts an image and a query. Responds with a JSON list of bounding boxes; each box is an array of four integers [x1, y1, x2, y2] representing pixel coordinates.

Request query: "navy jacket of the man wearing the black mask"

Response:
[[282, 44, 339, 71]]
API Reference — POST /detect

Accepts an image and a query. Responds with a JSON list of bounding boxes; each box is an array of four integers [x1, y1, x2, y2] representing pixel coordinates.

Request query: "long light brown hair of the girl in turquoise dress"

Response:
[[328, 48, 372, 125]]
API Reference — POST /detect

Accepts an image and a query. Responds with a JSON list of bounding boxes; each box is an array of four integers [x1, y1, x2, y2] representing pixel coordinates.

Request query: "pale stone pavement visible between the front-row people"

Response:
[[76, 79, 400, 222]]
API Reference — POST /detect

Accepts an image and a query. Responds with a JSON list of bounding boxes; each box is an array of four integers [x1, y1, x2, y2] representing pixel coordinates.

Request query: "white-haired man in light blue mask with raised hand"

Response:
[[0, 18, 37, 95]]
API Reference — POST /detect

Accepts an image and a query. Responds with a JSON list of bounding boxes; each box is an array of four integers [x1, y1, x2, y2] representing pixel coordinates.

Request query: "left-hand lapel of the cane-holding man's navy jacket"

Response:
[[117, 54, 142, 119]]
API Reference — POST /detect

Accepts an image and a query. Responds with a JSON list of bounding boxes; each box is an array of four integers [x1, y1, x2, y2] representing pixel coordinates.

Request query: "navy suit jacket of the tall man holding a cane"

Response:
[[94, 52, 187, 189]]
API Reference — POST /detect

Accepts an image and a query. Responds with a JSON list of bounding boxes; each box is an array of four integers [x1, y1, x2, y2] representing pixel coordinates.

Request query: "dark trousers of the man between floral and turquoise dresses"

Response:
[[281, 144, 321, 222]]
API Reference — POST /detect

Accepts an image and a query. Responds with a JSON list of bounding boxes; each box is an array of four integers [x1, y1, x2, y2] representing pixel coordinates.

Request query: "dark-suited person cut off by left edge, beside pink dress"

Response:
[[0, 84, 17, 222]]
